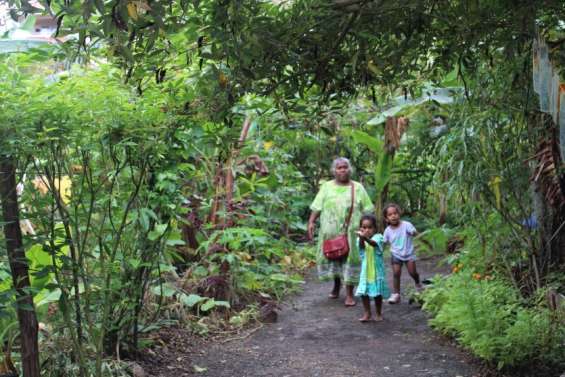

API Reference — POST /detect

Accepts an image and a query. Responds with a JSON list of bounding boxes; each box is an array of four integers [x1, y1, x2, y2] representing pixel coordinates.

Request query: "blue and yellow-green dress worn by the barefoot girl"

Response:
[[355, 234, 390, 299]]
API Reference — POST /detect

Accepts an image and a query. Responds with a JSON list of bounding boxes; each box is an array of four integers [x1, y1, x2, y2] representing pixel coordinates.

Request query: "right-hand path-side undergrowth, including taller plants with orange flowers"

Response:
[[423, 219, 565, 375]]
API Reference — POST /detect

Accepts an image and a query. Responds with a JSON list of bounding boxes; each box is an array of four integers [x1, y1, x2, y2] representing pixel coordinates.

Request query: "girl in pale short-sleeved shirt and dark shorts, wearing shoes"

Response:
[[383, 203, 422, 304]]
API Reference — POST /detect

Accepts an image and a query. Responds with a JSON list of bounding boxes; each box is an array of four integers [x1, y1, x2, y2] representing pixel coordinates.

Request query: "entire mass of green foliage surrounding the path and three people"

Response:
[[0, 0, 565, 376]]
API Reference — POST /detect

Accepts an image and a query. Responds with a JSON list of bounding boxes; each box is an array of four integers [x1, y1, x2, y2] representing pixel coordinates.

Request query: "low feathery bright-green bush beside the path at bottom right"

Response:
[[423, 270, 565, 368]]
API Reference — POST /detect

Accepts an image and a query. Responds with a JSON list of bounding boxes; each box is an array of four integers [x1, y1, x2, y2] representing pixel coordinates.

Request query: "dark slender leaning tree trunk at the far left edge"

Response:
[[0, 156, 40, 377]]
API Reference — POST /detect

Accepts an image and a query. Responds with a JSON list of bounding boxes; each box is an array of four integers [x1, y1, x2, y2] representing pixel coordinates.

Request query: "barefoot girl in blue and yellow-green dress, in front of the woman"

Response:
[[355, 215, 390, 322]]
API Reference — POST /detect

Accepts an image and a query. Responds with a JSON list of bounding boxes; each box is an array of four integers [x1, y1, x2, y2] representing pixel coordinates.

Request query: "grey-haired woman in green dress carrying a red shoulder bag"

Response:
[[308, 157, 373, 306]]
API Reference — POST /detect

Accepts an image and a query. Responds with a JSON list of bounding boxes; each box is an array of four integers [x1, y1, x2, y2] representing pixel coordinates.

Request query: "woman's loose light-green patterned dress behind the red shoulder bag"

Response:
[[310, 180, 373, 285]]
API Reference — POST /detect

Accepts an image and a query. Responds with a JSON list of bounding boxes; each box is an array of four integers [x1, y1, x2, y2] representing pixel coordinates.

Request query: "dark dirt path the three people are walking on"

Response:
[[143, 260, 479, 377]]
